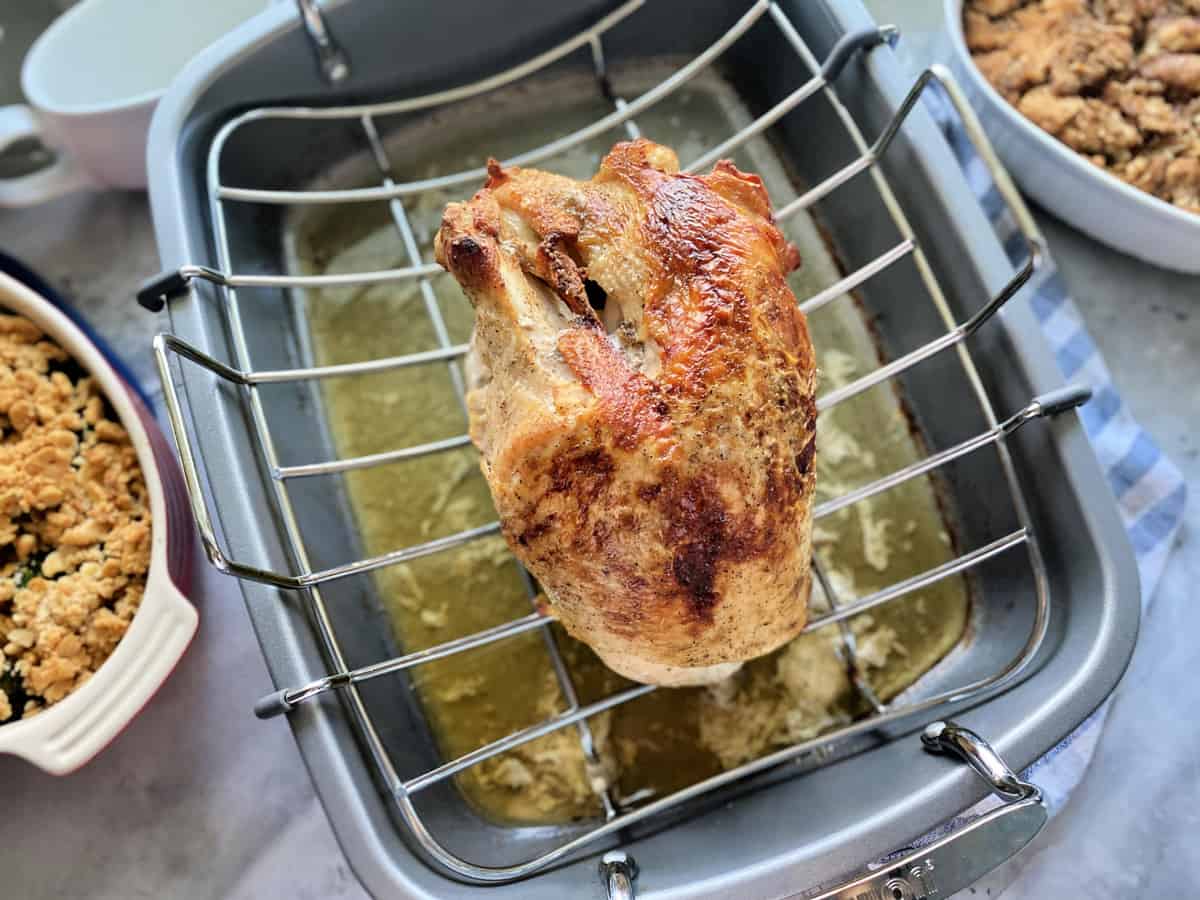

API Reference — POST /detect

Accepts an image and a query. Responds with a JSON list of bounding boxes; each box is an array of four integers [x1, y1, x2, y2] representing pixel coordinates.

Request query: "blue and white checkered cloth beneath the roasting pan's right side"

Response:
[[925, 91, 1187, 815]]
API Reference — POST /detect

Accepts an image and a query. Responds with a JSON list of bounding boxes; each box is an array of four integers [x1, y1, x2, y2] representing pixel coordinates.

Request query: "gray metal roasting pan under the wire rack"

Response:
[[140, 0, 1139, 900]]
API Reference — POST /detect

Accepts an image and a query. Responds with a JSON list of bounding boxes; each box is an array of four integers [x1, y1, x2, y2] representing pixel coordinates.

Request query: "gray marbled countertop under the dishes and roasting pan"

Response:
[[0, 8, 1200, 900]]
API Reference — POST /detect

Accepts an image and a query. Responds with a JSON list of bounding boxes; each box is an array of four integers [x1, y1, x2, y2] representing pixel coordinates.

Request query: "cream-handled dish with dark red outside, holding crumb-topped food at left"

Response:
[[0, 272, 199, 775]]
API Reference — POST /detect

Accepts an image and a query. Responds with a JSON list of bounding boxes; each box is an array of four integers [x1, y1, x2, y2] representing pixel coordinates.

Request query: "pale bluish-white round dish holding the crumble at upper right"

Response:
[[944, 0, 1200, 274]]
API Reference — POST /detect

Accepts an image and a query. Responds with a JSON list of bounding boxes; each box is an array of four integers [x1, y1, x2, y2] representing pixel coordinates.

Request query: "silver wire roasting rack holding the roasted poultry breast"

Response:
[[151, 0, 1086, 882]]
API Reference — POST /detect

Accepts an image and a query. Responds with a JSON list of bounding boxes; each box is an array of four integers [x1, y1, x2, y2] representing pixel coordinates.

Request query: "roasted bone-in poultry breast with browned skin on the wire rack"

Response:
[[436, 140, 816, 684]]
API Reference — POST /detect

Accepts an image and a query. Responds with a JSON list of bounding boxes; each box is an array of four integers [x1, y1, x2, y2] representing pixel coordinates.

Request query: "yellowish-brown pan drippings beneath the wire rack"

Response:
[[292, 73, 970, 824]]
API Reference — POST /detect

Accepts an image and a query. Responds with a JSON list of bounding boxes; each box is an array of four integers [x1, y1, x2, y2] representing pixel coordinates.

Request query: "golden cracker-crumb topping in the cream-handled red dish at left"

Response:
[[0, 314, 150, 722]]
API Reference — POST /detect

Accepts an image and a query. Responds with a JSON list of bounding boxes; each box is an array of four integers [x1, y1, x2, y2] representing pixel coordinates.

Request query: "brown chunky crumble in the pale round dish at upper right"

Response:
[[964, 0, 1200, 212]]
